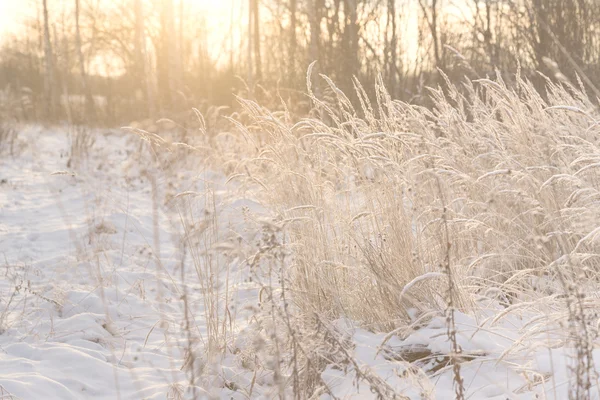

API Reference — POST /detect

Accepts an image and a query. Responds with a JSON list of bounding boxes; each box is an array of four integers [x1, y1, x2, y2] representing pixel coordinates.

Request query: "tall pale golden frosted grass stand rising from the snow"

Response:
[[205, 69, 600, 399]]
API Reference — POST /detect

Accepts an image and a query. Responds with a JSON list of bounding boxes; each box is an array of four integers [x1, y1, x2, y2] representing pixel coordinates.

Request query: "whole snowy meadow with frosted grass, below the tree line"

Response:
[[0, 72, 600, 400]]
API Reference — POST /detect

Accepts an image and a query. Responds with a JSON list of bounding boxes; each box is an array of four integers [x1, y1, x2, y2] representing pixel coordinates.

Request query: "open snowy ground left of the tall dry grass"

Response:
[[0, 127, 268, 399]]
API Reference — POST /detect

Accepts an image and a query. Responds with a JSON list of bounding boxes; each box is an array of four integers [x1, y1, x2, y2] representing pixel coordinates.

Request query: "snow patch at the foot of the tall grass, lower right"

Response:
[[321, 309, 600, 400]]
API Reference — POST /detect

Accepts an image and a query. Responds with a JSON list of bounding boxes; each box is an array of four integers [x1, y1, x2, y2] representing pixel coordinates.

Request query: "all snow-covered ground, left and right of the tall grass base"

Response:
[[0, 123, 600, 400]]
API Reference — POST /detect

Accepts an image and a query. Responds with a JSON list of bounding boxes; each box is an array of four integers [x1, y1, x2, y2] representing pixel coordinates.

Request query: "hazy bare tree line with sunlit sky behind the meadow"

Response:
[[0, 0, 600, 122]]
